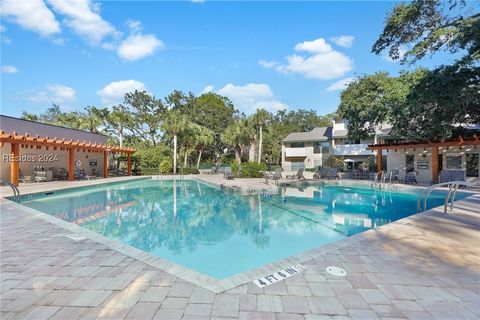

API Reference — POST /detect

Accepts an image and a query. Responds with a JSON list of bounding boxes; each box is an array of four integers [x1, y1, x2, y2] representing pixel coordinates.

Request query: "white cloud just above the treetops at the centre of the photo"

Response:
[[217, 83, 287, 114]]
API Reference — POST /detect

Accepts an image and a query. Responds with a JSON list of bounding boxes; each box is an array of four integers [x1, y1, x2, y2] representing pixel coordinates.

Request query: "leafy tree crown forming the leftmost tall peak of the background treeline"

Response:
[[124, 90, 167, 146]]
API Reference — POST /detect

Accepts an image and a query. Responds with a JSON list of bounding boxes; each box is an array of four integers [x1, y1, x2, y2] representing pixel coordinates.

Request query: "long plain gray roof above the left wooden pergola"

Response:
[[0, 115, 108, 144]]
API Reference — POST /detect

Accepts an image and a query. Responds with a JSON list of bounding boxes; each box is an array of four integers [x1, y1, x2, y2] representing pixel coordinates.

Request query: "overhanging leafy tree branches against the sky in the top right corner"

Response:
[[372, 0, 480, 64]]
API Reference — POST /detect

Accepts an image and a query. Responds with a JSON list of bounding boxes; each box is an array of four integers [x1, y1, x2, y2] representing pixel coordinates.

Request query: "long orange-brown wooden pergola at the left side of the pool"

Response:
[[0, 131, 135, 186]]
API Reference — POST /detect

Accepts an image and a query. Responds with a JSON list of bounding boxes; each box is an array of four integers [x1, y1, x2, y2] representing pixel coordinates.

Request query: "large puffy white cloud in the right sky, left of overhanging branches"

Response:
[[259, 38, 353, 80]]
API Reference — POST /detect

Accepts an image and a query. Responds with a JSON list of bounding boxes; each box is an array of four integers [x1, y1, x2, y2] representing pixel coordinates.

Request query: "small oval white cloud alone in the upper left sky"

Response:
[[117, 34, 163, 61]]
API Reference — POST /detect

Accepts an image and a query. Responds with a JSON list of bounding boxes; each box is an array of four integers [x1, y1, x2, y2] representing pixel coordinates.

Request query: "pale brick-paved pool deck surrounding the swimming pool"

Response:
[[0, 177, 480, 320]]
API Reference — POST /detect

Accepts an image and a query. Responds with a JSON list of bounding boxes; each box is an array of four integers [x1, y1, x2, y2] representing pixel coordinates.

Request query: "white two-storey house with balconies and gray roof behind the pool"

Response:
[[282, 127, 332, 171]]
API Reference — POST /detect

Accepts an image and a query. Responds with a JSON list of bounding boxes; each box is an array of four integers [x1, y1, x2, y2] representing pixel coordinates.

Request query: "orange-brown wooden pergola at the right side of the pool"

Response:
[[368, 135, 480, 183]]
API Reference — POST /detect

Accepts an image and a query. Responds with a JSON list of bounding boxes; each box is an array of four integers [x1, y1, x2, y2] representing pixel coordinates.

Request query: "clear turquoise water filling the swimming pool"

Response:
[[16, 179, 466, 279]]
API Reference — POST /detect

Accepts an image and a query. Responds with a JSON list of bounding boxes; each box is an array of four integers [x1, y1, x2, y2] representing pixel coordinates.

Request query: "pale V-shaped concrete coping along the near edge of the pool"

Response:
[[3, 176, 480, 293]]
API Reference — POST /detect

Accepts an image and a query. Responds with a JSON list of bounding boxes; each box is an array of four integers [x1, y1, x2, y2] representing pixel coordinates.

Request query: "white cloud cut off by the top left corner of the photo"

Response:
[[0, 0, 60, 37]]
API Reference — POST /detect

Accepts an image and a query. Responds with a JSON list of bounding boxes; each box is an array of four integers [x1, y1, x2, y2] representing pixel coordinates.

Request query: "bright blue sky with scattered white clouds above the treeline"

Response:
[[0, 0, 454, 116]]
